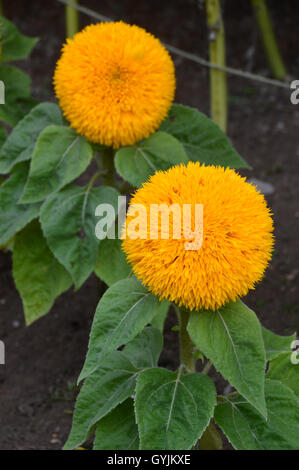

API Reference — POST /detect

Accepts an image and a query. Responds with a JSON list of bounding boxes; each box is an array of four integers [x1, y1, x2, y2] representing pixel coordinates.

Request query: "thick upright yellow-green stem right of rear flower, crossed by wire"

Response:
[[206, 0, 227, 132]]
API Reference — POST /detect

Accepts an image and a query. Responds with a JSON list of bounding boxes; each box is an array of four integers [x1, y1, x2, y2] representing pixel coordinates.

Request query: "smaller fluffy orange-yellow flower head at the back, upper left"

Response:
[[54, 21, 175, 148]]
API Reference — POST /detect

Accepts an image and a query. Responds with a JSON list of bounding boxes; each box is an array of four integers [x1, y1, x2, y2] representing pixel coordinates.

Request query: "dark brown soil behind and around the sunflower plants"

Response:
[[0, 0, 299, 449]]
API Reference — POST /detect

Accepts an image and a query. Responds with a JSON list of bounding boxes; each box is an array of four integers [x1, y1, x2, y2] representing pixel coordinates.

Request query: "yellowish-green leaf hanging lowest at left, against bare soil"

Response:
[[13, 220, 71, 324]]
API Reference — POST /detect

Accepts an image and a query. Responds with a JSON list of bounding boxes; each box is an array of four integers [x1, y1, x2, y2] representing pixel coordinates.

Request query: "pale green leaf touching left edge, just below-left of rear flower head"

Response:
[[0, 103, 63, 173]]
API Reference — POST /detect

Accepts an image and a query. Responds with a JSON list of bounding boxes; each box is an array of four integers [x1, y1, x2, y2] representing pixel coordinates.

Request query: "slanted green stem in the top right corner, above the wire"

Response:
[[251, 0, 287, 80]]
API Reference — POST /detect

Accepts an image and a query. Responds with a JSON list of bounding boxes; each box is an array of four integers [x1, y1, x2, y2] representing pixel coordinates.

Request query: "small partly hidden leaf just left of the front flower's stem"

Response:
[[123, 327, 163, 369]]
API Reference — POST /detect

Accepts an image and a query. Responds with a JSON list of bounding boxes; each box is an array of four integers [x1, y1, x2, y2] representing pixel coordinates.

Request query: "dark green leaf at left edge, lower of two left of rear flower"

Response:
[[0, 65, 36, 127]]
